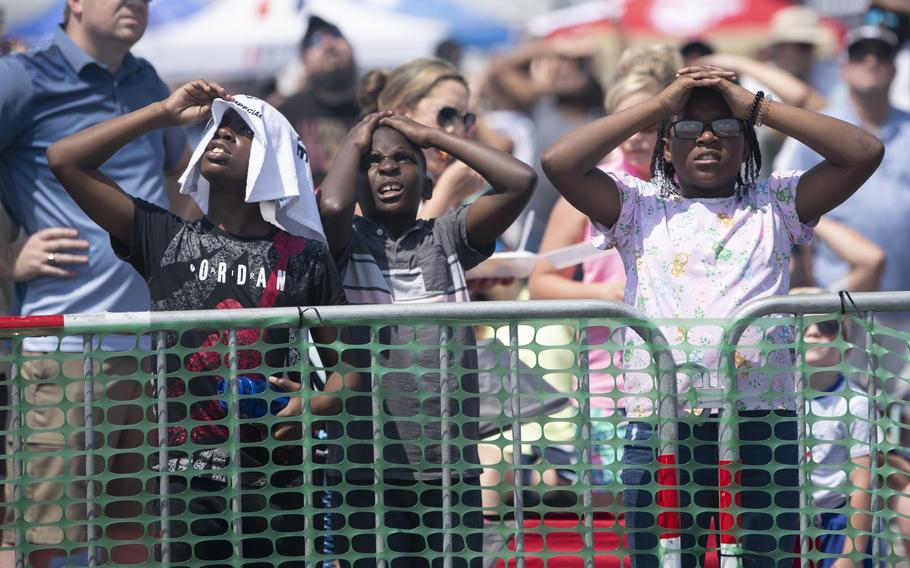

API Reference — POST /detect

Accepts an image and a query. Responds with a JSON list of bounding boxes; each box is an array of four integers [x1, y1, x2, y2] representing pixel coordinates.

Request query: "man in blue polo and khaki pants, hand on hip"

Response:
[[0, 0, 189, 565]]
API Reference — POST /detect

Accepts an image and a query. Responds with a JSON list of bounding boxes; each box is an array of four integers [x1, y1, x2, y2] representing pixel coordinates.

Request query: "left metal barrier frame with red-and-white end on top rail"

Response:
[[0, 300, 680, 568]]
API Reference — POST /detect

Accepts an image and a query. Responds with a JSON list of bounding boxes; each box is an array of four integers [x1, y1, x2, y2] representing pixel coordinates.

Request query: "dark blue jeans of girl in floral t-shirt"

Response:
[[620, 411, 799, 568]]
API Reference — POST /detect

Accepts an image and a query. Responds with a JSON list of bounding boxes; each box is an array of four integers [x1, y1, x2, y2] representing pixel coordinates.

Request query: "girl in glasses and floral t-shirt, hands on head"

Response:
[[542, 67, 884, 566]]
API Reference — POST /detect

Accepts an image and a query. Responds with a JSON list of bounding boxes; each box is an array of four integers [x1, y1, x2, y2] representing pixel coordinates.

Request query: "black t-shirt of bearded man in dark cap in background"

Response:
[[278, 90, 360, 186]]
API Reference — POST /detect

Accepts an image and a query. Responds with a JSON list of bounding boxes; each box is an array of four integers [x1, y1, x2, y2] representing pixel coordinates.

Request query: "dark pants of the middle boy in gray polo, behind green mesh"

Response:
[[316, 477, 483, 568]]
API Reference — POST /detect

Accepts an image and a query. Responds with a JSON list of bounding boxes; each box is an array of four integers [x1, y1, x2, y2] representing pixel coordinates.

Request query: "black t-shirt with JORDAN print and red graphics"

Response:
[[111, 199, 345, 480]]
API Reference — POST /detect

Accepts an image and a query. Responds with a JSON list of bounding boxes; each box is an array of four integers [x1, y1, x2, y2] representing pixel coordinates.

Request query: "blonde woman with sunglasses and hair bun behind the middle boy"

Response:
[[357, 57, 485, 219]]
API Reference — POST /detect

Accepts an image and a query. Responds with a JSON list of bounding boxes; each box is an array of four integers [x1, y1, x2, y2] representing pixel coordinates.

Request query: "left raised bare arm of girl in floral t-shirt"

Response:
[[540, 68, 735, 227]]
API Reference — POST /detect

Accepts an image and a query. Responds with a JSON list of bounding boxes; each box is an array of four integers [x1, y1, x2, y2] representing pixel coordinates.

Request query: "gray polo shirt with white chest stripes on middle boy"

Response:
[[332, 206, 493, 480]]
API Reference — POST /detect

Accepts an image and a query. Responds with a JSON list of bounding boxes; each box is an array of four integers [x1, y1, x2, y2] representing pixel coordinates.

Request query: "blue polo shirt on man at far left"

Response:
[[0, 29, 186, 351]]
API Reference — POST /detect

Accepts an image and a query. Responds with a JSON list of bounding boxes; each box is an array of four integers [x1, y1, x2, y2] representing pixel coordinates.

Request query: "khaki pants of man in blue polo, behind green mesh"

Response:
[[3, 352, 144, 545]]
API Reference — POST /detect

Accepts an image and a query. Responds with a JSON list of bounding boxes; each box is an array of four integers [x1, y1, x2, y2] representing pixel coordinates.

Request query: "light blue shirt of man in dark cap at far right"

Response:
[[774, 102, 910, 324]]
